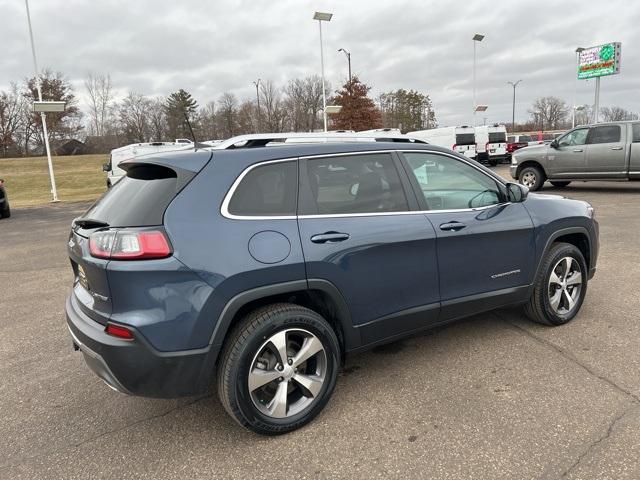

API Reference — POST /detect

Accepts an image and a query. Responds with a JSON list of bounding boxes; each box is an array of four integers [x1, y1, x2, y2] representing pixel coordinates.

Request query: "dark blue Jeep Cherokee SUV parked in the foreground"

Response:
[[66, 142, 598, 434]]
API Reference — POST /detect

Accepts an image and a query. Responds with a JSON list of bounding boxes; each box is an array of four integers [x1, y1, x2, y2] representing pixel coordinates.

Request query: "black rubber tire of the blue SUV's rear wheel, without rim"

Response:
[[217, 303, 340, 435]]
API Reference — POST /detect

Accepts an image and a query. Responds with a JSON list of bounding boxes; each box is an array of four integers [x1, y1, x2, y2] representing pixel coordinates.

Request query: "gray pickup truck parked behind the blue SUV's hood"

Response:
[[511, 121, 640, 190]]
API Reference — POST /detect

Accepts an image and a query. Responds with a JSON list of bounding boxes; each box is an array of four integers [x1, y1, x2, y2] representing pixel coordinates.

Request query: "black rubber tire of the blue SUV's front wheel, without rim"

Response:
[[524, 242, 587, 326]]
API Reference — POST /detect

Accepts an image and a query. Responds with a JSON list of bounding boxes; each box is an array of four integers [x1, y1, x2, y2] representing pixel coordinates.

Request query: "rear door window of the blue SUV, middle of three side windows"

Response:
[[307, 153, 409, 215]]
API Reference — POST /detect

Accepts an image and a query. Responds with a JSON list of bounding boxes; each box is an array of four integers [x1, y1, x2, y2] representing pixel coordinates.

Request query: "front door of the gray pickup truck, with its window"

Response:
[[547, 128, 589, 178]]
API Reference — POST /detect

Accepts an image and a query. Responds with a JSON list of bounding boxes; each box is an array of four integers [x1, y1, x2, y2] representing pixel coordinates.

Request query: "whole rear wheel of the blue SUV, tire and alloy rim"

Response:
[[218, 304, 340, 435]]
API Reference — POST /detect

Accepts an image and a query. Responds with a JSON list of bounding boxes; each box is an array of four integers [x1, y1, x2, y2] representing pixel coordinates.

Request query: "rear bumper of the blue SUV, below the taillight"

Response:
[[66, 295, 216, 398]]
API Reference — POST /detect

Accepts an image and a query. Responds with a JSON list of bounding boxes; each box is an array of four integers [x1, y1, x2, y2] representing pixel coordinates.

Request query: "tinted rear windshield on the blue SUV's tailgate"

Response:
[[82, 165, 178, 227]]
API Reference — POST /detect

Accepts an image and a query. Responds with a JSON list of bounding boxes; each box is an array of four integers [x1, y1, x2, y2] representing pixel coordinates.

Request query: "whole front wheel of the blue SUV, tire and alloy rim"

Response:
[[525, 243, 587, 325]]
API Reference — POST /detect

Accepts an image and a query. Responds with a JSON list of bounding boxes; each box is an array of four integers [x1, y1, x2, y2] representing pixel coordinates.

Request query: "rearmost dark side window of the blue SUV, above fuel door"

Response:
[[228, 160, 298, 217]]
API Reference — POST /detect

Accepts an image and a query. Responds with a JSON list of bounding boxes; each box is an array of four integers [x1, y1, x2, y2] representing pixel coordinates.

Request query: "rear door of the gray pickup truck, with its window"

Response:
[[586, 125, 627, 178]]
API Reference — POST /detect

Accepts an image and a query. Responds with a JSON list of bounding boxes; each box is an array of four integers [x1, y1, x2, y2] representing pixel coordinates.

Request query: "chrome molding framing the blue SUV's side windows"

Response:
[[220, 148, 511, 220]]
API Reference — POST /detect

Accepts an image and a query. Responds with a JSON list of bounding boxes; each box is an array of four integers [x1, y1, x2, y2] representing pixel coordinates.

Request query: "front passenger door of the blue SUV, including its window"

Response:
[[403, 152, 535, 320]]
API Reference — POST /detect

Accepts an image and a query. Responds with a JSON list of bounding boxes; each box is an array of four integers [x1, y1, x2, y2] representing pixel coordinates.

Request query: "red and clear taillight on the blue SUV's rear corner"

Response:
[[89, 230, 171, 260]]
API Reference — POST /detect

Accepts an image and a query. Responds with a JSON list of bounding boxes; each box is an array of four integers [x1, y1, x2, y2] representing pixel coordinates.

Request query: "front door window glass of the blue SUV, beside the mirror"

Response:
[[403, 152, 503, 210]]
